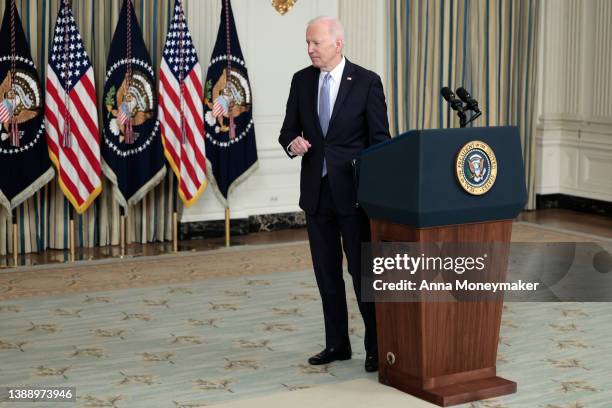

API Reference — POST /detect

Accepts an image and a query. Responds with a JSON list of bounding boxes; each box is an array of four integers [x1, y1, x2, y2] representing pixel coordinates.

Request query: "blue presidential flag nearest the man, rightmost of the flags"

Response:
[[204, 0, 257, 207]]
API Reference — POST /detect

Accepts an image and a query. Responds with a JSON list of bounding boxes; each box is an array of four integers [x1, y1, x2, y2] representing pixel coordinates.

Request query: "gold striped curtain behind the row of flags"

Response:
[[0, 0, 180, 254]]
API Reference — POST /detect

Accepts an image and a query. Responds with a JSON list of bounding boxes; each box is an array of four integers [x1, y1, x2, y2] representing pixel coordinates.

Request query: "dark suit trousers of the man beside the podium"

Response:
[[306, 176, 377, 354]]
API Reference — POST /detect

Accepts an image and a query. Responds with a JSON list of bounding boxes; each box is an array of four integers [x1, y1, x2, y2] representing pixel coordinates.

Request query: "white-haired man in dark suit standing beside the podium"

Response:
[[278, 17, 389, 371]]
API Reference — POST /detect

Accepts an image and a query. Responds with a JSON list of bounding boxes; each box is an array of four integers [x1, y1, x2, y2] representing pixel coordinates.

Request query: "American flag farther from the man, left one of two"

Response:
[[45, 0, 102, 214]]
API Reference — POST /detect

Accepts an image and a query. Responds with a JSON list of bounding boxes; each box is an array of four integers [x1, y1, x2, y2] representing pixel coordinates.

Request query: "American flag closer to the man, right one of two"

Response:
[[159, 0, 207, 207]]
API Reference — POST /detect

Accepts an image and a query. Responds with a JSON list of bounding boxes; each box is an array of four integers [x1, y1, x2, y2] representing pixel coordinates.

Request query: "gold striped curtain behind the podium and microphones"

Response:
[[388, 0, 540, 208]]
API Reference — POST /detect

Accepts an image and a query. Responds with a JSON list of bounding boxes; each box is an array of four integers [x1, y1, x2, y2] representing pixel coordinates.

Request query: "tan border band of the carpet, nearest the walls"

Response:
[[0, 222, 593, 301]]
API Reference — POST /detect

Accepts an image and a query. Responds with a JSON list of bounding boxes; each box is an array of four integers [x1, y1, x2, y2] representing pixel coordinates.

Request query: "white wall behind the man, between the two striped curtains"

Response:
[[181, 0, 386, 222]]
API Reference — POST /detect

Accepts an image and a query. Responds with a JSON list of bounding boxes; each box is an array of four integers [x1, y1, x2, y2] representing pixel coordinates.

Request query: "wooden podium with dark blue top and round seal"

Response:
[[358, 127, 526, 406]]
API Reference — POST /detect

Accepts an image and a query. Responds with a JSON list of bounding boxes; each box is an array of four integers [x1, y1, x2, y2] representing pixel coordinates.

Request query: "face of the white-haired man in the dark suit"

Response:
[[306, 21, 342, 71]]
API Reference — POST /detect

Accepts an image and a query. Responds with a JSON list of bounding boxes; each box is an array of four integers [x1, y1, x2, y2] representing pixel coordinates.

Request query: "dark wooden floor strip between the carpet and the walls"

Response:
[[0, 209, 612, 268]]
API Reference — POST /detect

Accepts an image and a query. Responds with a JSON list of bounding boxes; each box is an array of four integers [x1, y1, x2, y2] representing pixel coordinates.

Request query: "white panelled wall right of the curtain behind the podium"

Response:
[[536, 0, 612, 201]]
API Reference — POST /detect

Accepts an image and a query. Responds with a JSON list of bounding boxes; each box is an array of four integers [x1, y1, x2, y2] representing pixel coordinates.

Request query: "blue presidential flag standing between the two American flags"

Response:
[[101, 0, 166, 209]]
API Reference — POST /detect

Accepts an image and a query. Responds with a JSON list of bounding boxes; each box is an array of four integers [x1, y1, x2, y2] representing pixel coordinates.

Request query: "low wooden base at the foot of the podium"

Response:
[[381, 377, 516, 407]]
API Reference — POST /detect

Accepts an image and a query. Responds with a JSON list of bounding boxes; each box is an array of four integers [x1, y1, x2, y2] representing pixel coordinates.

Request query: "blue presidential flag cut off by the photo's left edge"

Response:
[[0, 0, 54, 217]]
